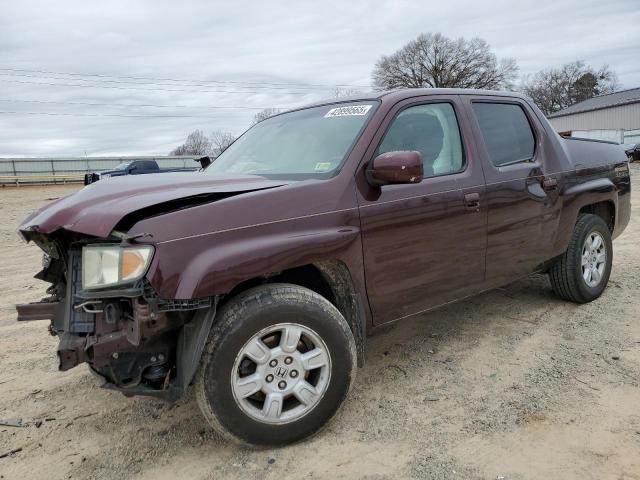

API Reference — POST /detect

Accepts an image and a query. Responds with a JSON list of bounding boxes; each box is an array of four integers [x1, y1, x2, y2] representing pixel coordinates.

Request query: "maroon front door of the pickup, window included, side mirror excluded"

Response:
[[358, 95, 487, 324]]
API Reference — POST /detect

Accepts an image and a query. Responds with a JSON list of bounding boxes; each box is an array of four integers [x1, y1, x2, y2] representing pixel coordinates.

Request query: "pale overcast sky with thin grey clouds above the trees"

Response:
[[0, 0, 640, 157]]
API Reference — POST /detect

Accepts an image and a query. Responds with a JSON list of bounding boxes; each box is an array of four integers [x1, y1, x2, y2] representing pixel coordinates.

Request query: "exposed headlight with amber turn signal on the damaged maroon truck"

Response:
[[82, 245, 153, 290]]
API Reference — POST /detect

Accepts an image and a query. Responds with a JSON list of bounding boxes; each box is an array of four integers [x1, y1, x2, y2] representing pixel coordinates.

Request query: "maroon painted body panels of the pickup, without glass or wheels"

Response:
[[20, 89, 630, 346]]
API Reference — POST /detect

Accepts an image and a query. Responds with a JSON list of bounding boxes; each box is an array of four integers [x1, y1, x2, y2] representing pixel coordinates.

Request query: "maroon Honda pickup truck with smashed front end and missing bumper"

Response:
[[17, 89, 630, 445]]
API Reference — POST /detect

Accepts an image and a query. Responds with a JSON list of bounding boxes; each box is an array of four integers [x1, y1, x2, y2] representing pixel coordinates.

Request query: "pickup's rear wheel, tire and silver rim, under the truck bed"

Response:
[[549, 214, 613, 303]]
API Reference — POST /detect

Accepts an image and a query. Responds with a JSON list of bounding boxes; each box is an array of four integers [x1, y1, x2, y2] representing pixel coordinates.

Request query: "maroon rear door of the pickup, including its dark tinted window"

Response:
[[464, 96, 559, 287]]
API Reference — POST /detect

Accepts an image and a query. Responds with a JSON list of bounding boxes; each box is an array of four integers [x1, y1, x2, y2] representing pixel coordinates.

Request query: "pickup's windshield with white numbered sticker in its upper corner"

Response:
[[205, 102, 376, 179]]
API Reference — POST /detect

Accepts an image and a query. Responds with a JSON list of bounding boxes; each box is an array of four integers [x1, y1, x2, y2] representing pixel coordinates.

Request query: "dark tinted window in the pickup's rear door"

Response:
[[472, 102, 535, 167]]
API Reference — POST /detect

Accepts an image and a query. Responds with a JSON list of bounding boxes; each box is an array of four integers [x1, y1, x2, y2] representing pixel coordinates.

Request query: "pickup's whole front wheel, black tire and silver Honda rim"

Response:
[[195, 284, 356, 445]]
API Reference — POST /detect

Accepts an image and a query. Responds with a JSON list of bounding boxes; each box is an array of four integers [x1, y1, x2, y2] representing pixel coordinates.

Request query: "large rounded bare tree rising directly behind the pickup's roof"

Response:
[[372, 33, 518, 89]]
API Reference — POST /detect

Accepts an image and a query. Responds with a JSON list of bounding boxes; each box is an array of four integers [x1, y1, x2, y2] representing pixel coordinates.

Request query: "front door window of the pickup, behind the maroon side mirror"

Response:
[[378, 103, 464, 178]]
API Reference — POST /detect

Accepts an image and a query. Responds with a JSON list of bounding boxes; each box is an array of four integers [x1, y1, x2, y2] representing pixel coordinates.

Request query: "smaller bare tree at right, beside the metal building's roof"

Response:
[[522, 60, 618, 115]]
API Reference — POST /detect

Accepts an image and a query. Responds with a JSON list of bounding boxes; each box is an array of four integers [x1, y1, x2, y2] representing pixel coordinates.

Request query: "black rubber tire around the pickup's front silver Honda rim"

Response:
[[195, 284, 357, 446]]
